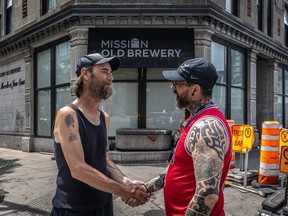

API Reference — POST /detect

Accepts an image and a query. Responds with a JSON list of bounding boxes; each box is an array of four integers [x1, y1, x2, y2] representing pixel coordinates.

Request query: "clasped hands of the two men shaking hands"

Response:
[[120, 178, 153, 207]]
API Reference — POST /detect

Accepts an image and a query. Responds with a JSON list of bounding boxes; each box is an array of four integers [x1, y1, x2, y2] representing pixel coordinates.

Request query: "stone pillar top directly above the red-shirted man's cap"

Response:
[[194, 28, 214, 60]]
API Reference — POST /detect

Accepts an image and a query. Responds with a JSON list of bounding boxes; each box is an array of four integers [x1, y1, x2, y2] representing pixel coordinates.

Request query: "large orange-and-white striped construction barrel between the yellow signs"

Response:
[[258, 121, 281, 185]]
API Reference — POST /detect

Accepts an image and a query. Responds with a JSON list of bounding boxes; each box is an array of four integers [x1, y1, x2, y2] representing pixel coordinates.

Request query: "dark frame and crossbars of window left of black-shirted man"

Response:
[[33, 37, 71, 138]]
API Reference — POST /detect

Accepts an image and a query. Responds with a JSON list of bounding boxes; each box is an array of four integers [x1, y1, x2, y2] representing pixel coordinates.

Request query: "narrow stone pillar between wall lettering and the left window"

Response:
[[22, 49, 34, 152]]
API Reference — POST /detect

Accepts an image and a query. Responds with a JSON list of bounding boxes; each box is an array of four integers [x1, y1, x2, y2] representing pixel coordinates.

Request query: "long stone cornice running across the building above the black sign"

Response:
[[0, 4, 288, 64]]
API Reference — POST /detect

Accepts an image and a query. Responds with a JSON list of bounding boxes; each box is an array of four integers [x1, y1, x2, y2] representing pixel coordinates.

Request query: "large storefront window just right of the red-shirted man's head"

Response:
[[211, 42, 246, 124]]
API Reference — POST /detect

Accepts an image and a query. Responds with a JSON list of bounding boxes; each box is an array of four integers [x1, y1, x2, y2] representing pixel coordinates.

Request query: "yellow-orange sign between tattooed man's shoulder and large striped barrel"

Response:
[[231, 125, 254, 153]]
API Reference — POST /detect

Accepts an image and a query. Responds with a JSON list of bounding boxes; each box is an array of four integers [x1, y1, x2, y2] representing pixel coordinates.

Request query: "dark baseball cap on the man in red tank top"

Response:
[[162, 58, 218, 90]]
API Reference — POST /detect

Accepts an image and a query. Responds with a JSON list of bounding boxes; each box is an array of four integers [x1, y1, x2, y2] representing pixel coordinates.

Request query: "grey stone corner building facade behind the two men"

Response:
[[0, 0, 288, 152]]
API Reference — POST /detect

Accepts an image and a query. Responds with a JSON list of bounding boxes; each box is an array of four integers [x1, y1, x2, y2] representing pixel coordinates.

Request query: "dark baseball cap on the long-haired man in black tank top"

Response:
[[75, 53, 120, 77]]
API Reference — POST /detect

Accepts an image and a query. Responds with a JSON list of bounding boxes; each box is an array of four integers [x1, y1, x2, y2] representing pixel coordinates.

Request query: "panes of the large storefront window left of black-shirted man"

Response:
[[35, 42, 71, 137]]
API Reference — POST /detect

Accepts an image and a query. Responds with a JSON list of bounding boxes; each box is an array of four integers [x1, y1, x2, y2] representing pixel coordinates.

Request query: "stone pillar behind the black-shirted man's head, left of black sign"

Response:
[[69, 27, 88, 100]]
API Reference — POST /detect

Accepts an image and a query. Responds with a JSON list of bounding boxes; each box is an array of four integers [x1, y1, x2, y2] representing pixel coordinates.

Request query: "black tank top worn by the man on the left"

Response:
[[52, 104, 111, 211]]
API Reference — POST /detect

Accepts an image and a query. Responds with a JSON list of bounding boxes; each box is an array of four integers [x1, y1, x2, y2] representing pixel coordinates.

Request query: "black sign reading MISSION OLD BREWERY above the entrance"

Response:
[[88, 28, 194, 68]]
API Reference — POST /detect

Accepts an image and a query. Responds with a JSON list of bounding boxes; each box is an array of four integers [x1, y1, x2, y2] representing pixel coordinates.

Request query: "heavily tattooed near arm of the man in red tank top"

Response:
[[185, 117, 227, 216]]
